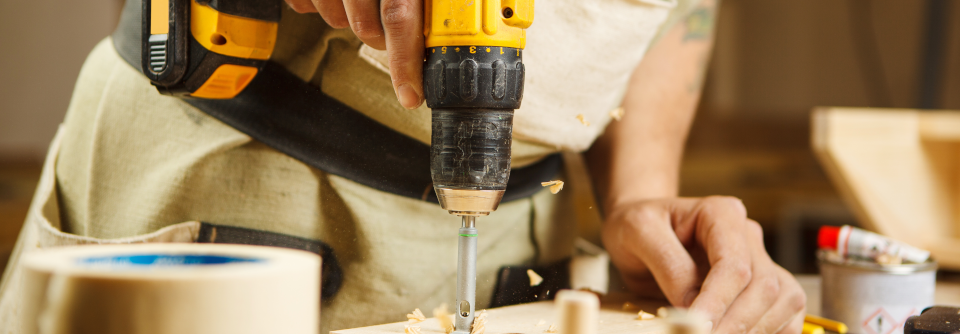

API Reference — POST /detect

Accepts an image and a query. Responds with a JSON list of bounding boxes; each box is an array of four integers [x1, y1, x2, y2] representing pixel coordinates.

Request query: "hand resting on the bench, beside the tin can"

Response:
[[603, 197, 806, 334]]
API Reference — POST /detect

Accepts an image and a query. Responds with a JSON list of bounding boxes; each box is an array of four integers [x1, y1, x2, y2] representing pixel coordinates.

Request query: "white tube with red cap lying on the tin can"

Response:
[[817, 225, 930, 263]]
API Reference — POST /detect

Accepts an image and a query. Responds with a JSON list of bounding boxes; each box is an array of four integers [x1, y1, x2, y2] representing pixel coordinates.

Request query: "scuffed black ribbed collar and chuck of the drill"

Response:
[[423, 46, 524, 190]]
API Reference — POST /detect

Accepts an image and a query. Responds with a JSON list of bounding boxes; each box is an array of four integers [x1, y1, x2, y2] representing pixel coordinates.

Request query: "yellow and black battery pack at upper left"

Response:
[[141, 0, 281, 99]]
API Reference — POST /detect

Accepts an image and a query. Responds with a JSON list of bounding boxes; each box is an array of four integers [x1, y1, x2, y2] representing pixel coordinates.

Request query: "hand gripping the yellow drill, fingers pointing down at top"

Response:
[[286, 0, 423, 109]]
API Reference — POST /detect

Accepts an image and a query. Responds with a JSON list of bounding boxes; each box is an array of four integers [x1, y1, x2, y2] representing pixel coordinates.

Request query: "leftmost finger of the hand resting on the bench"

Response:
[[621, 205, 700, 307]]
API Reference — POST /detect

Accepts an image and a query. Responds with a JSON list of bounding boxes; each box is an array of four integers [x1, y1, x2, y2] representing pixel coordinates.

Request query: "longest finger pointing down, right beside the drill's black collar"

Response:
[[380, 0, 424, 109]]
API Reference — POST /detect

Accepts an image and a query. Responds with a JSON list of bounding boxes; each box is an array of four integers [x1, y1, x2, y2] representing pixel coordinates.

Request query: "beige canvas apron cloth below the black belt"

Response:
[[0, 39, 599, 333]]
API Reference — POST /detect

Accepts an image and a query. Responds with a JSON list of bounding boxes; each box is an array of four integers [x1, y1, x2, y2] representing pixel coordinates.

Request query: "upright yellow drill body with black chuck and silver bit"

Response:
[[423, 0, 533, 333]]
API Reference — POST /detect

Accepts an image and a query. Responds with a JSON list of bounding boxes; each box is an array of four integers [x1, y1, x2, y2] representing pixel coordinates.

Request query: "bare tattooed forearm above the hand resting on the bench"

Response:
[[587, 0, 716, 212]]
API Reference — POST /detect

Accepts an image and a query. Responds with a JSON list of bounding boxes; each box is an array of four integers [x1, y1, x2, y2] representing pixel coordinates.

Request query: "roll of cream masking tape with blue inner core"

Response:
[[21, 244, 320, 334]]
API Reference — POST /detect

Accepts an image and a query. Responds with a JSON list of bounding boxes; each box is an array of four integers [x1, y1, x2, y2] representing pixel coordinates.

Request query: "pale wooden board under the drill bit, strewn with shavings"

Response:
[[331, 298, 667, 334]]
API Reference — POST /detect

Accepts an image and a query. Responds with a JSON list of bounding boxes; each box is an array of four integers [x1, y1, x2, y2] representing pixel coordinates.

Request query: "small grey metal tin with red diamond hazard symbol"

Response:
[[817, 250, 937, 334]]
